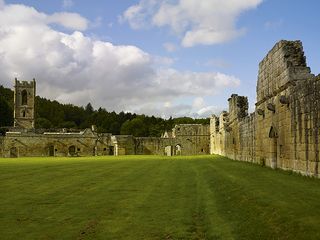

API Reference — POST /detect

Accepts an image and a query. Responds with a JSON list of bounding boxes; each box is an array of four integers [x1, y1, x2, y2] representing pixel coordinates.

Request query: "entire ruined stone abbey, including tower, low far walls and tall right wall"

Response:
[[0, 41, 320, 176]]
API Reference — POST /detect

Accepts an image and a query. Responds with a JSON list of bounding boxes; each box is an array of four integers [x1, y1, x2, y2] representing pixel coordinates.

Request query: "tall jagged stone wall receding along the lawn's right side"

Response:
[[210, 41, 320, 176]]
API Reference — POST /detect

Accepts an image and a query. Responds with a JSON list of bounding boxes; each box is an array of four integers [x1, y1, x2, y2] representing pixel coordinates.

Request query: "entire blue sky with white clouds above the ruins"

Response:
[[0, 0, 320, 118]]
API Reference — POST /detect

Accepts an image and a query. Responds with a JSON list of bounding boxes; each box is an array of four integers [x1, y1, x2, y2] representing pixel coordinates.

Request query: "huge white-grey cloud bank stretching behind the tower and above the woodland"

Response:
[[0, 0, 240, 116]]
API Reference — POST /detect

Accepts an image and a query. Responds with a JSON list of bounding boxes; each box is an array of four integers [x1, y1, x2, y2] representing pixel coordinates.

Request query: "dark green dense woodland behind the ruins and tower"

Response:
[[0, 86, 209, 137]]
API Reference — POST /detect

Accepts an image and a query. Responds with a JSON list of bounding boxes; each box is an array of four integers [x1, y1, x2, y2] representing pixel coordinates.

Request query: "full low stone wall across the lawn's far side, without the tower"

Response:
[[0, 124, 209, 157]]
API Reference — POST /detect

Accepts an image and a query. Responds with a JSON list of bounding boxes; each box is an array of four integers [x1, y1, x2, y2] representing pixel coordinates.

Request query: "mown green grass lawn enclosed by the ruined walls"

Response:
[[0, 156, 320, 240]]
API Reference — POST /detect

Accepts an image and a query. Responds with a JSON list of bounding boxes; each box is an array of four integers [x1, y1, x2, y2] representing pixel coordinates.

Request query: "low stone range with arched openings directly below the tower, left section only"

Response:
[[1, 130, 113, 157]]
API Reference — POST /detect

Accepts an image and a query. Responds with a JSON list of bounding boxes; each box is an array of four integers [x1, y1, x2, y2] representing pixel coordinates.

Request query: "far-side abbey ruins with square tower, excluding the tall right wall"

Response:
[[0, 79, 210, 157]]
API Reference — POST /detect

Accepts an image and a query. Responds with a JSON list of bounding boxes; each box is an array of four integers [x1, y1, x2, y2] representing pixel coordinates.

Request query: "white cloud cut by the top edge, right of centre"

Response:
[[121, 0, 262, 47]]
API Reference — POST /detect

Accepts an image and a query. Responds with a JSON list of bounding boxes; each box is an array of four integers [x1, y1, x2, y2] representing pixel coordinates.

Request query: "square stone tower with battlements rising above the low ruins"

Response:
[[14, 78, 36, 129]]
